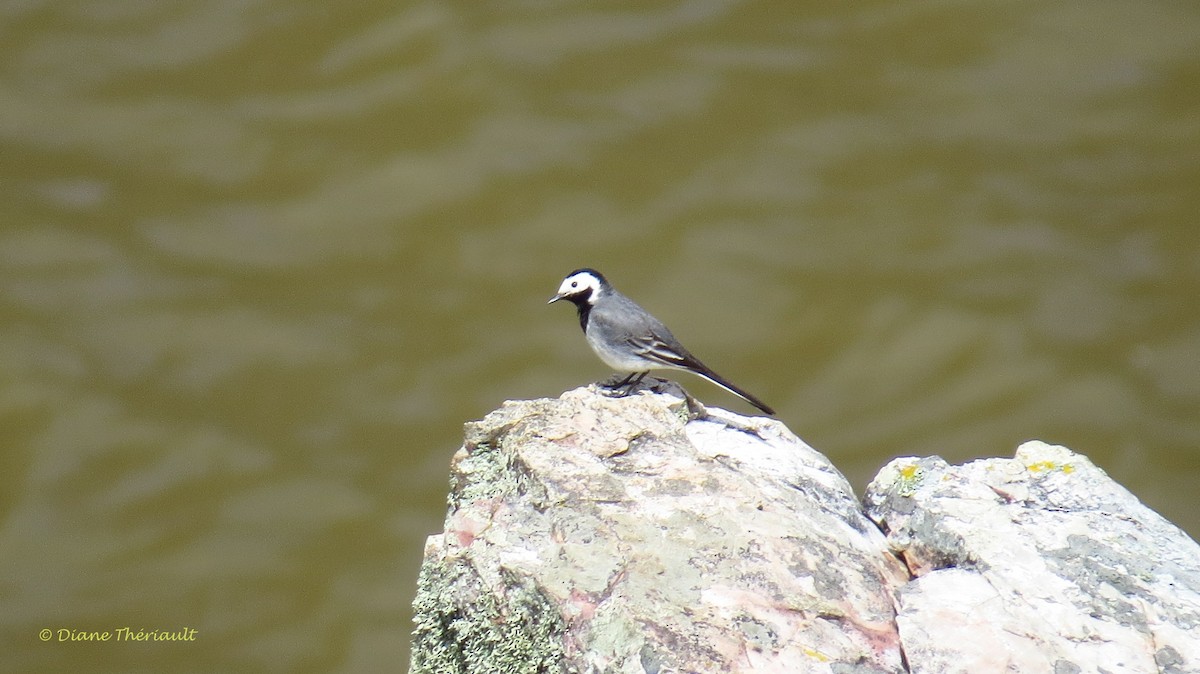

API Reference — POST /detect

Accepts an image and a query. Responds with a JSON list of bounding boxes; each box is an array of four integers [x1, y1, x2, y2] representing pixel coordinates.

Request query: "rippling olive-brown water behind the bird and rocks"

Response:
[[0, 0, 1200, 673]]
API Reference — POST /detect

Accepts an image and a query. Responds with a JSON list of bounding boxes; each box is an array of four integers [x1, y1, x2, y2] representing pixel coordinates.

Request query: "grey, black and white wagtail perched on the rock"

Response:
[[548, 269, 775, 414]]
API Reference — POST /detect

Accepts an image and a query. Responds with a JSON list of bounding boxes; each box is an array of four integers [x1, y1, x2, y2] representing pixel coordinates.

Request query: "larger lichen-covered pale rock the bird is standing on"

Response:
[[410, 384, 908, 674]]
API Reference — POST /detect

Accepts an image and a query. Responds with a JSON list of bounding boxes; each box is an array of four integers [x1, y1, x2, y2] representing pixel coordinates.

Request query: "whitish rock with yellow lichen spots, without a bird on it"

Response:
[[866, 441, 1200, 674]]
